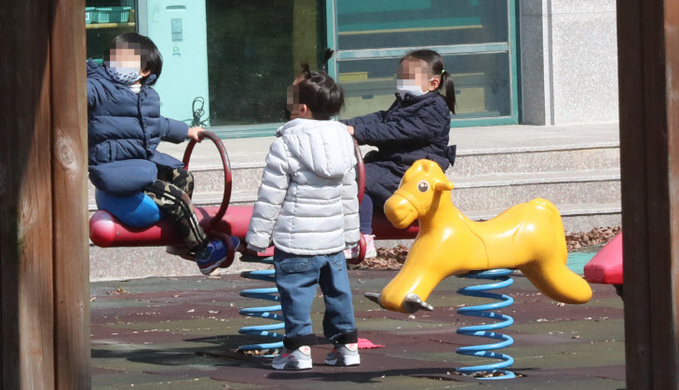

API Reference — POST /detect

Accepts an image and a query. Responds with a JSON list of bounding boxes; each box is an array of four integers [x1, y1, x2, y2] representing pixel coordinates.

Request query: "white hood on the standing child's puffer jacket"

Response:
[[276, 118, 356, 178]]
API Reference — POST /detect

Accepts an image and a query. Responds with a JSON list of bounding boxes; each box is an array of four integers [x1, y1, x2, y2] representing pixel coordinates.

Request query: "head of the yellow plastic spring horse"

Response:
[[384, 160, 453, 229]]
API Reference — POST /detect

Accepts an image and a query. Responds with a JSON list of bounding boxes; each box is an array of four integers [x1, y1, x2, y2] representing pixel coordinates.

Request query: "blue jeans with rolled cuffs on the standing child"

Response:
[[273, 249, 358, 349]]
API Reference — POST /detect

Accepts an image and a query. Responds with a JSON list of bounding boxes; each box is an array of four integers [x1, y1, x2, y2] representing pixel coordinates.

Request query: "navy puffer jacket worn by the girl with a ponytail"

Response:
[[342, 91, 455, 207]]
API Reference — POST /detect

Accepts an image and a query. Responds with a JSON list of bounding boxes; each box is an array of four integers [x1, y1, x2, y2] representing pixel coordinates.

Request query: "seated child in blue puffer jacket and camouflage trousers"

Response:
[[87, 33, 227, 275]]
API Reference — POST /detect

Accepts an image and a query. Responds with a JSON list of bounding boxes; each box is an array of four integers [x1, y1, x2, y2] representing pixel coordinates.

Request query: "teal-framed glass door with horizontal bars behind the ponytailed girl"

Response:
[[326, 0, 518, 126]]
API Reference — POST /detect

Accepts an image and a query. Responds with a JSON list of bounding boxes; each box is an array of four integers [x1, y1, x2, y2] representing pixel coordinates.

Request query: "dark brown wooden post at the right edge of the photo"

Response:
[[617, 0, 679, 389]]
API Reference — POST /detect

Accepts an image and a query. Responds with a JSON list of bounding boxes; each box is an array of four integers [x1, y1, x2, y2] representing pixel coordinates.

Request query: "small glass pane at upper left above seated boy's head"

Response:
[[85, 0, 137, 65]]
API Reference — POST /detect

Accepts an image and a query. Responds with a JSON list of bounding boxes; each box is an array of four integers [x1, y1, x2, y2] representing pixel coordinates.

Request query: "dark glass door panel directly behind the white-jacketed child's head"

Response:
[[206, 0, 325, 138]]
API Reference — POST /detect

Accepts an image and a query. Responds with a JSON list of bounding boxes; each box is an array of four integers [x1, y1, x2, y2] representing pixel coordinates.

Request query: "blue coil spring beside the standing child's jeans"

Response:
[[238, 256, 285, 356]]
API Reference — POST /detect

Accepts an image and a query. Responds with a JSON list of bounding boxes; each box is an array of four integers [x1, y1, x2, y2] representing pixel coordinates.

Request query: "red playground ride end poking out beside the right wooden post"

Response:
[[585, 233, 623, 297]]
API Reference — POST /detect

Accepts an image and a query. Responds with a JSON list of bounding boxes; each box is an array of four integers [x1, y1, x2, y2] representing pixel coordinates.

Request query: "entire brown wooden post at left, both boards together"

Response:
[[0, 0, 90, 390]]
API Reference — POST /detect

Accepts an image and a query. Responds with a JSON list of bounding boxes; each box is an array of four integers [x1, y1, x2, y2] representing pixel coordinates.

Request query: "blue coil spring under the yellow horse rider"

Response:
[[456, 269, 515, 379]]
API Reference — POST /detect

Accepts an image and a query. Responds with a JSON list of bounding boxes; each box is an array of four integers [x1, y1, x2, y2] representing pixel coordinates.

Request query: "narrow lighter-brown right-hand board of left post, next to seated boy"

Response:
[[50, 0, 91, 389]]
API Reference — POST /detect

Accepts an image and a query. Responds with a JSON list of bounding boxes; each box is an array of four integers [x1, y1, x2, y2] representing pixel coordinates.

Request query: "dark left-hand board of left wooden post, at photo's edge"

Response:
[[0, 0, 54, 389]]
